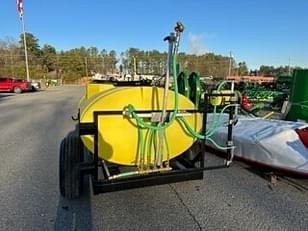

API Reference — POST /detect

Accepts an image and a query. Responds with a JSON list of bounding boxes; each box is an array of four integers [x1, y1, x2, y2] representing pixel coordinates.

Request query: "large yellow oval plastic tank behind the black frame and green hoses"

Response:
[[80, 84, 201, 166]]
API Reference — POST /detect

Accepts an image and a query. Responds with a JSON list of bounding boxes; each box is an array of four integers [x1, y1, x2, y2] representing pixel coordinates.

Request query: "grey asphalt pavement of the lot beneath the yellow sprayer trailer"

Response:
[[0, 86, 308, 231]]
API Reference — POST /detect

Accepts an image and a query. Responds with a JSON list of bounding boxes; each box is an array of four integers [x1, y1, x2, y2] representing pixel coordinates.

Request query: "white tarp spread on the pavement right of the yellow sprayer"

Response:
[[207, 114, 308, 174]]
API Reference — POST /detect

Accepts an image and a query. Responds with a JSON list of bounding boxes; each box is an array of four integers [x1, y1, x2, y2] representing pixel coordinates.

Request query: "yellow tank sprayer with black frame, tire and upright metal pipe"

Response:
[[59, 23, 236, 199]]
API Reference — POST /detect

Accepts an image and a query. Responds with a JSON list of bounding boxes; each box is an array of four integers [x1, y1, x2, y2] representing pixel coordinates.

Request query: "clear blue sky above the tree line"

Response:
[[0, 0, 308, 69]]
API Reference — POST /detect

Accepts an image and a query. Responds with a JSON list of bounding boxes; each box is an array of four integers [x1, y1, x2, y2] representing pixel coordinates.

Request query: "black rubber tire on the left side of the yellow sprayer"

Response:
[[59, 133, 83, 199]]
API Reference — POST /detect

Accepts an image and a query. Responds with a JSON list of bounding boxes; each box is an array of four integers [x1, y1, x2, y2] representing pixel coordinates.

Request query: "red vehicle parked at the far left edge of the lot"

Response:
[[0, 78, 32, 93]]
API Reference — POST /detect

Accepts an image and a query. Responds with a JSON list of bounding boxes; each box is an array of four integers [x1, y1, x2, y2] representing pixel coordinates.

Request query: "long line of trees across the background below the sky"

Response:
[[0, 33, 298, 80]]
